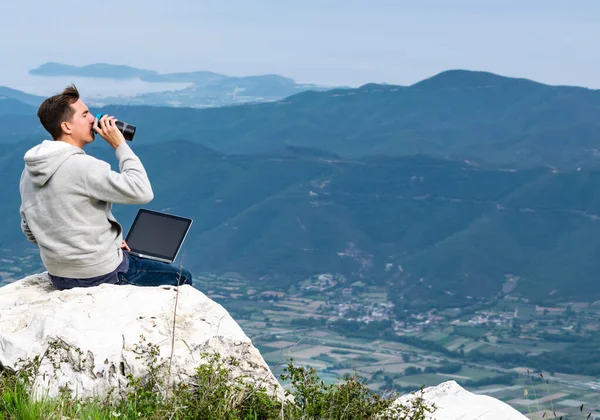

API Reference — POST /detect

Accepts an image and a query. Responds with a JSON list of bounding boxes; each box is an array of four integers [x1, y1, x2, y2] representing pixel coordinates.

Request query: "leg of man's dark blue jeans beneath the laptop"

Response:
[[117, 252, 192, 286]]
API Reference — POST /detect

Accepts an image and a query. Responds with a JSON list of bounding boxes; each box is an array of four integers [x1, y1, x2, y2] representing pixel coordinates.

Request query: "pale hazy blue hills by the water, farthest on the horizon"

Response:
[[29, 63, 331, 108]]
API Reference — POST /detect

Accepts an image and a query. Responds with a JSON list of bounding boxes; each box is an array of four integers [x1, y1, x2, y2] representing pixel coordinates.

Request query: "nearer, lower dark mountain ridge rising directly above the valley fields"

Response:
[[0, 140, 600, 310]]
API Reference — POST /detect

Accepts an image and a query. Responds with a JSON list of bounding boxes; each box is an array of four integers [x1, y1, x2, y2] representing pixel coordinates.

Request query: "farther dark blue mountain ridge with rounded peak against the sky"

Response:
[[0, 70, 600, 170]]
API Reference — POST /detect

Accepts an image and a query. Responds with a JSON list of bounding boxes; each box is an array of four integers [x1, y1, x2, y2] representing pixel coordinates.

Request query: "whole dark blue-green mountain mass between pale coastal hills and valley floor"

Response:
[[0, 71, 600, 308]]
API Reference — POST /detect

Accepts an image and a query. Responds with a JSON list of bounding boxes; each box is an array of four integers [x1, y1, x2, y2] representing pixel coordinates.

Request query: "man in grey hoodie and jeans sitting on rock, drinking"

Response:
[[20, 85, 192, 290]]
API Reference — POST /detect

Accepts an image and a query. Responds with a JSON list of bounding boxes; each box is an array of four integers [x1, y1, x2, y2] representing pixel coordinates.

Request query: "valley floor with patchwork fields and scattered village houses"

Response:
[[197, 273, 600, 418]]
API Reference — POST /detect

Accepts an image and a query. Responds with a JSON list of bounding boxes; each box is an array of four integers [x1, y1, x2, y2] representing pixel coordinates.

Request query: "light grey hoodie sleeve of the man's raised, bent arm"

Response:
[[79, 142, 154, 204]]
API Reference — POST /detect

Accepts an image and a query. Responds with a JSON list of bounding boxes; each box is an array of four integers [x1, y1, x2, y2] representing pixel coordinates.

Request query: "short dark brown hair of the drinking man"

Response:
[[38, 84, 79, 140]]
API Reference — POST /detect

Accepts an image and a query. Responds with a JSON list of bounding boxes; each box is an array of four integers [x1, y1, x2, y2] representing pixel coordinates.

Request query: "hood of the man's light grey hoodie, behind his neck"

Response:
[[24, 140, 85, 187]]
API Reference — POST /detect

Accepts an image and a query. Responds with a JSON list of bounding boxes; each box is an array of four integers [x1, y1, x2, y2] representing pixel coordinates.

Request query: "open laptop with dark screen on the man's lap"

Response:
[[125, 209, 192, 264]]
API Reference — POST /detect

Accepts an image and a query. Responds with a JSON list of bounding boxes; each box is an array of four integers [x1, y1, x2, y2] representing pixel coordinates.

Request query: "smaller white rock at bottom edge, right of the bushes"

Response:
[[394, 381, 527, 420]]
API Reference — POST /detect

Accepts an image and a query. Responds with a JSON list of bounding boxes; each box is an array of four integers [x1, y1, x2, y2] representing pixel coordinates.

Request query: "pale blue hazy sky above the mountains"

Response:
[[0, 0, 600, 88]]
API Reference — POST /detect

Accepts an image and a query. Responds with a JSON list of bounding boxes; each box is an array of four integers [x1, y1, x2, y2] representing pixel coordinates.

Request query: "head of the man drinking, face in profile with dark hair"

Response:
[[37, 85, 95, 147]]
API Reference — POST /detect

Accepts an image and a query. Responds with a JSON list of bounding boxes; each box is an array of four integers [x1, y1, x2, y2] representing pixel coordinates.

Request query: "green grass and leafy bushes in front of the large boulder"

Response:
[[0, 343, 435, 420]]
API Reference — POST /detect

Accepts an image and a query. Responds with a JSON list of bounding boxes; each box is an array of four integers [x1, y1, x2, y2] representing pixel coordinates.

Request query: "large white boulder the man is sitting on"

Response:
[[0, 273, 283, 398]]
